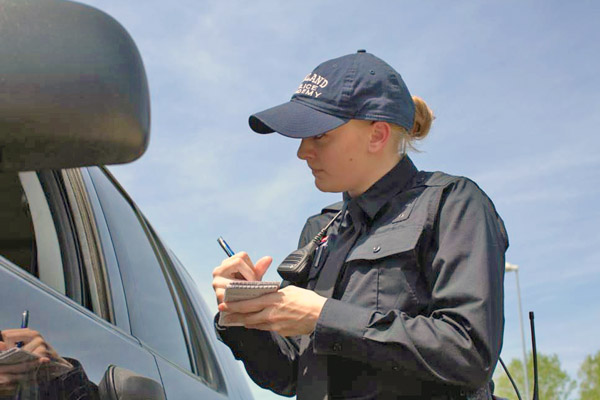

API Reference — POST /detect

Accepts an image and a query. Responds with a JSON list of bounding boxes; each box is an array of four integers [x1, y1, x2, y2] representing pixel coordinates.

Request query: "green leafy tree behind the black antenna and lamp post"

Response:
[[494, 353, 576, 400]]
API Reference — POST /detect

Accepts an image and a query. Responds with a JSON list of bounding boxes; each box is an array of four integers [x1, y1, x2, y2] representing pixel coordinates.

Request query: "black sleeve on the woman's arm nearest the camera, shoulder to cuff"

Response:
[[313, 179, 508, 388]]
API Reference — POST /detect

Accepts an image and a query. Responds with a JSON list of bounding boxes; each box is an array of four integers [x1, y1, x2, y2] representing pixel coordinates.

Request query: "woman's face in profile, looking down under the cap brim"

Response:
[[298, 120, 370, 196]]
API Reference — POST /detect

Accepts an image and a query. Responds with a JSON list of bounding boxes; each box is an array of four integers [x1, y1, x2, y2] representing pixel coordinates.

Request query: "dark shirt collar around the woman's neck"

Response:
[[343, 155, 417, 220]]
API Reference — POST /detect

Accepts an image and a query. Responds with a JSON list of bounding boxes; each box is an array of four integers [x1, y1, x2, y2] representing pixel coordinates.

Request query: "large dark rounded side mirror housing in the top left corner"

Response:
[[0, 0, 150, 172]]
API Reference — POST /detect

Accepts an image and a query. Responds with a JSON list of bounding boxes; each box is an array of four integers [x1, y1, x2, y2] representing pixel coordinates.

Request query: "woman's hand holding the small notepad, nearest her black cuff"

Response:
[[219, 286, 327, 336]]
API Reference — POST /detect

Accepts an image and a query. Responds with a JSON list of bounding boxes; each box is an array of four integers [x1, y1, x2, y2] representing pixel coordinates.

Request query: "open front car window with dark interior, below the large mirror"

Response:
[[0, 171, 103, 316]]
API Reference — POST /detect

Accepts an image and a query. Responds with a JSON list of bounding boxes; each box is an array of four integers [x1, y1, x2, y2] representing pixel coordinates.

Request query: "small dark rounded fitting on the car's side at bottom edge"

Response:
[[98, 365, 165, 400]]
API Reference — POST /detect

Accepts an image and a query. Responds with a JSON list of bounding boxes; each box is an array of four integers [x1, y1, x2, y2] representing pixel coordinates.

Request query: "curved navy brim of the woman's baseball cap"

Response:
[[248, 100, 350, 139]]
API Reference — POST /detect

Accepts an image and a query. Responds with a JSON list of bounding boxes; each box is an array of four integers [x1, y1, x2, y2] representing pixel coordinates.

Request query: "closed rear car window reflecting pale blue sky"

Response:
[[89, 168, 192, 371]]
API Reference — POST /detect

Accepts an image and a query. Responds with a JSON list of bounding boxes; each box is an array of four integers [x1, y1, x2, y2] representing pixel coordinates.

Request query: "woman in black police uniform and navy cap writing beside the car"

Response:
[[213, 50, 508, 400]]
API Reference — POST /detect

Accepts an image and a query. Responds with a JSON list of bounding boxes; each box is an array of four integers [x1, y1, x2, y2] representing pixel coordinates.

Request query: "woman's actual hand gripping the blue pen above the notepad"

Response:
[[213, 251, 273, 304]]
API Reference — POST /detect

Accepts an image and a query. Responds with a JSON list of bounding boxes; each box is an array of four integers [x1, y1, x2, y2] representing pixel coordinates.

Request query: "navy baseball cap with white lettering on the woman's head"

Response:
[[248, 50, 415, 138]]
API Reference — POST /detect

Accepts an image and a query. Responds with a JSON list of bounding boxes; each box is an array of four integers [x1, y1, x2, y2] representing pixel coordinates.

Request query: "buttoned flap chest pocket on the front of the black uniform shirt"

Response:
[[346, 227, 423, 315]]
